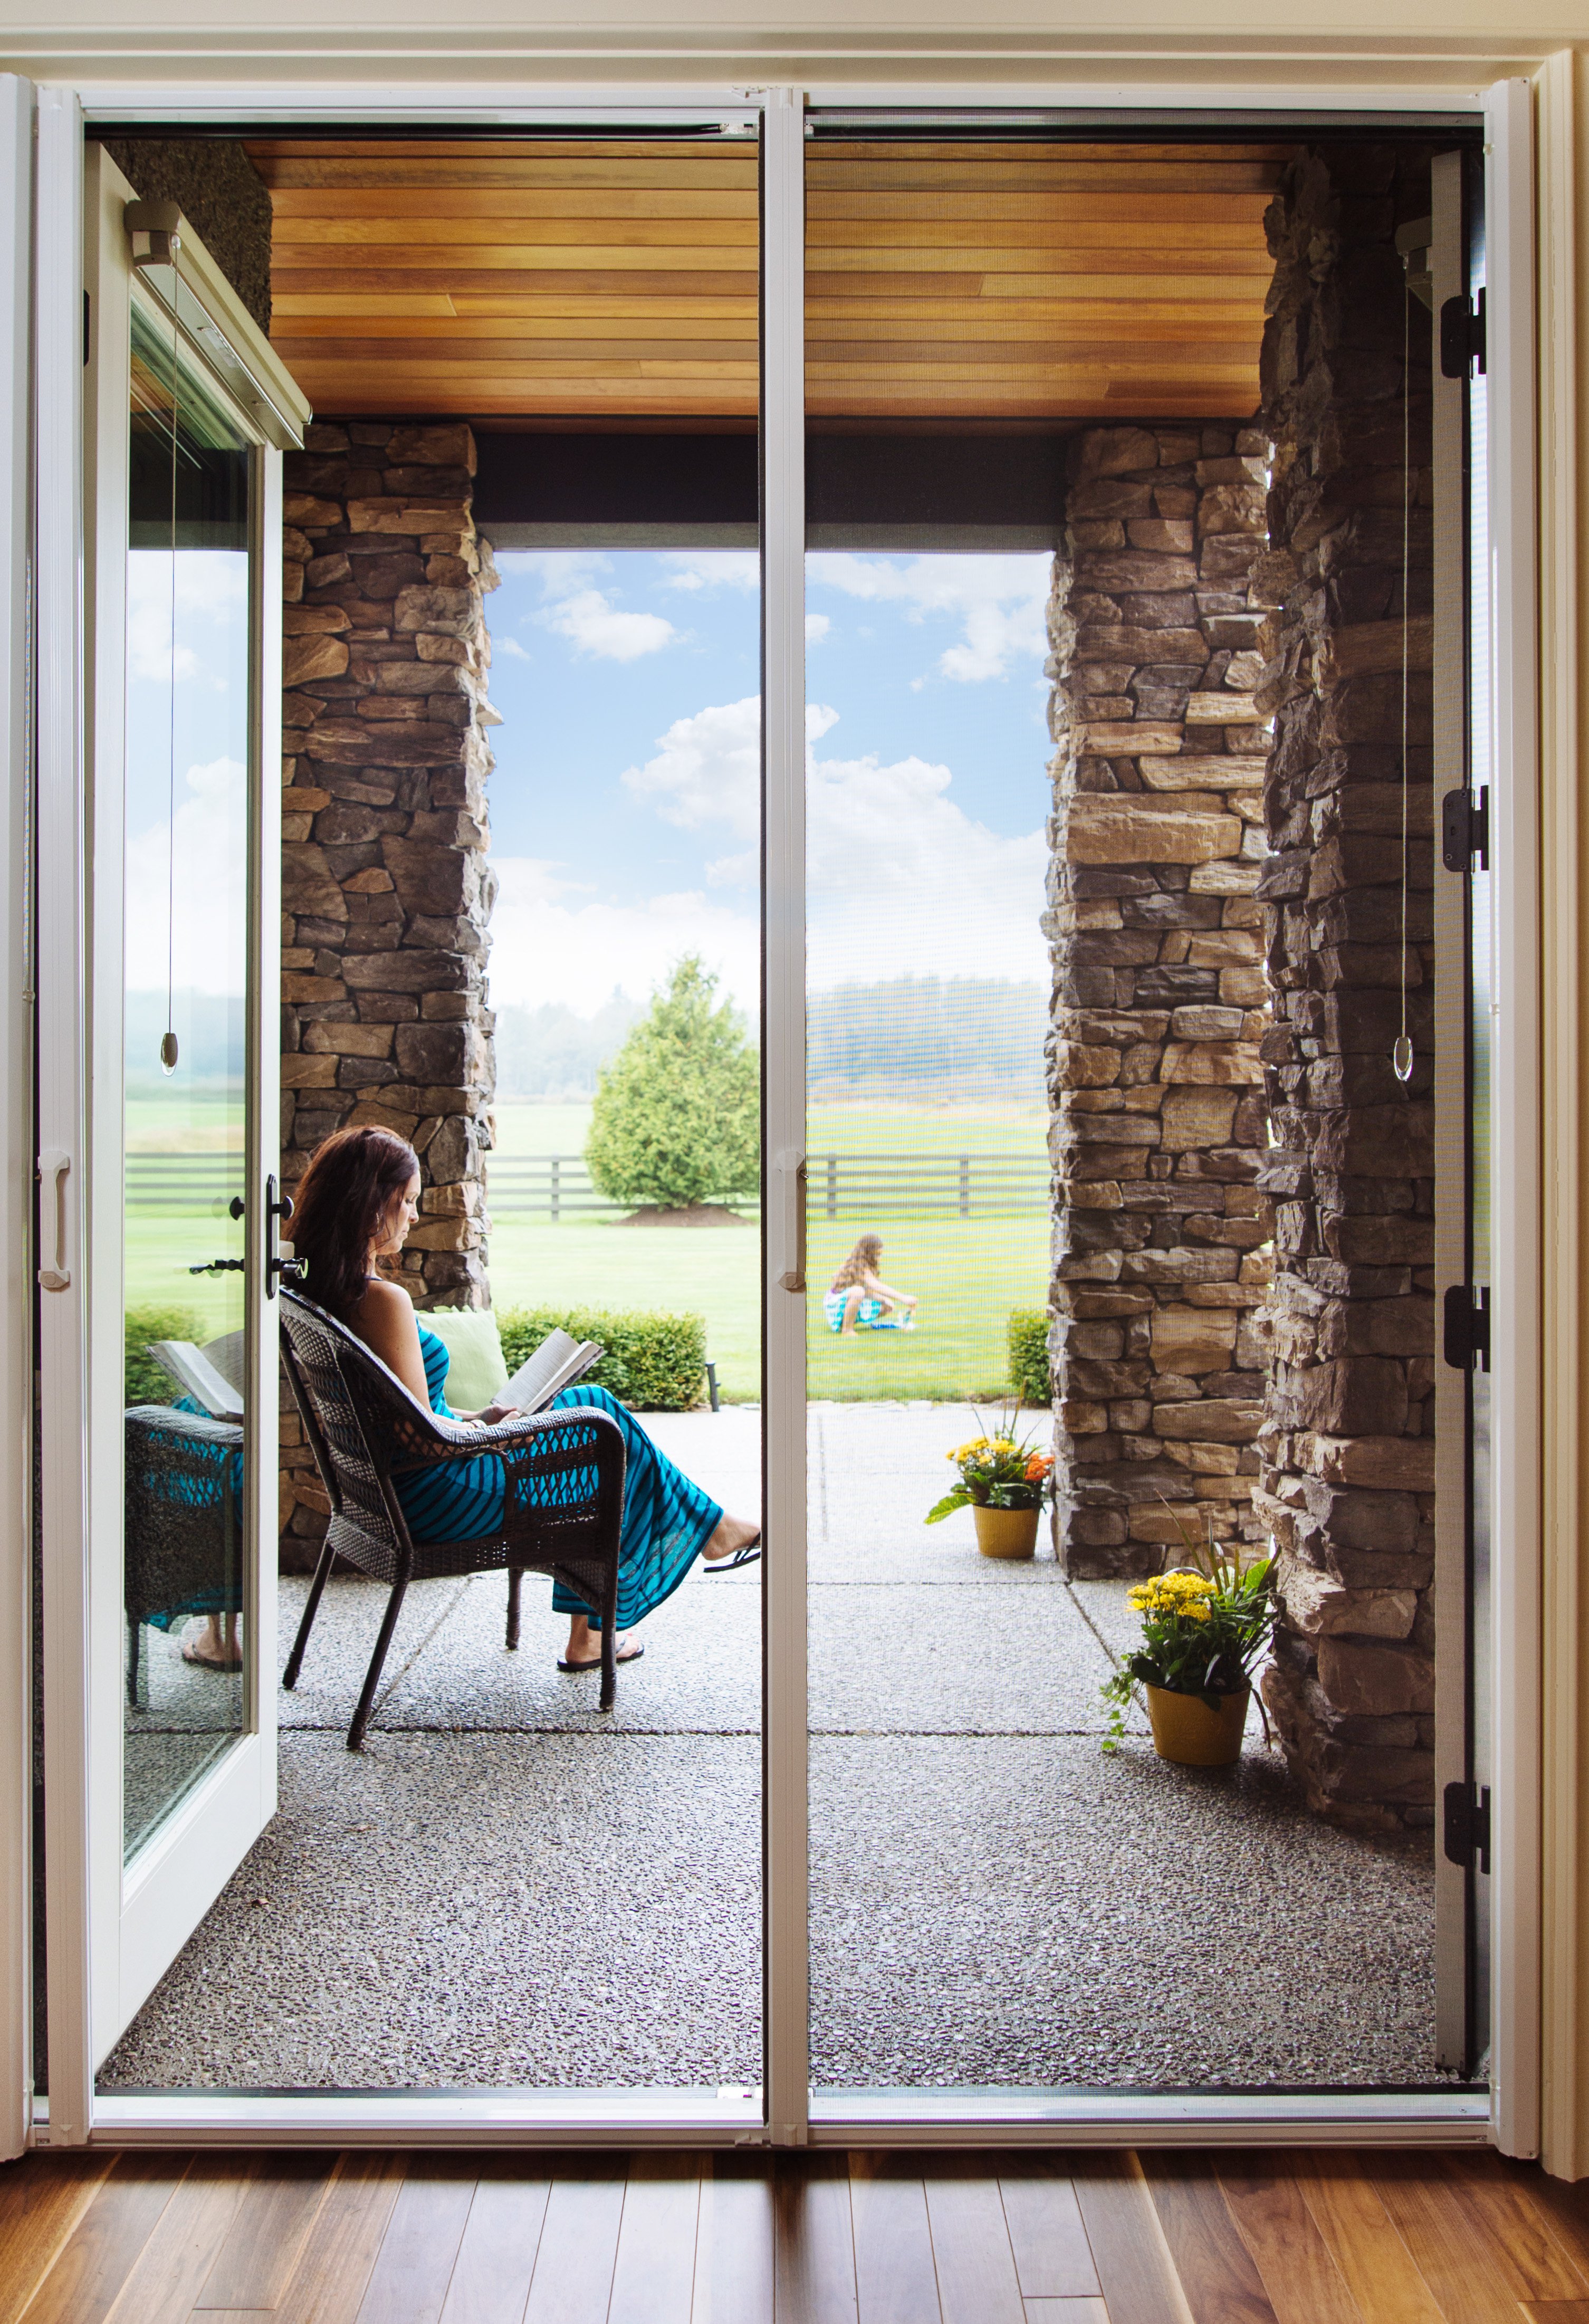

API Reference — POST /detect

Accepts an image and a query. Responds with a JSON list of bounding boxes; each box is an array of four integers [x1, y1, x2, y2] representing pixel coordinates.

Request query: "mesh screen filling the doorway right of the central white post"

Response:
[[806, 131, 1438, 2119]]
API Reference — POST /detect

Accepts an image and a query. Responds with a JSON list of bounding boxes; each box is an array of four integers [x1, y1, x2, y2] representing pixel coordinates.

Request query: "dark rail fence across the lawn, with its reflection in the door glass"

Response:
[[128, 1153, 1050, 1222]]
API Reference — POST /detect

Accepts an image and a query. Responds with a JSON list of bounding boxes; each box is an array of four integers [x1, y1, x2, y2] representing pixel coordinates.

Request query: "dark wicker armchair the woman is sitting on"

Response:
[[281, 1285, 623, 1750]]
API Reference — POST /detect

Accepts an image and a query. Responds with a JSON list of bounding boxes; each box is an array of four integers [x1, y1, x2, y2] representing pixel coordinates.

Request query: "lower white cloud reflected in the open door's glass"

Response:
[[126, 758, 248, 992]]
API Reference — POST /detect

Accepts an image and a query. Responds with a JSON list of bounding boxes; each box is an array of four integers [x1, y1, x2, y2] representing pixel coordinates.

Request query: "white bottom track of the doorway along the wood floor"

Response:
[[71, 2089, 1491, 2147]]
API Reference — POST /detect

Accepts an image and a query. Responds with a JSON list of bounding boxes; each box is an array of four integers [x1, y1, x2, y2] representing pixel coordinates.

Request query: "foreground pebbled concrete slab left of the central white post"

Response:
[[100, 1734, 762, 2089]]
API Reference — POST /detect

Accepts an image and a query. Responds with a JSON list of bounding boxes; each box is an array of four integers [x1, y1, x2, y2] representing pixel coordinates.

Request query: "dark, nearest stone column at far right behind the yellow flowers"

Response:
[[1257, 147, 1433, 1829]]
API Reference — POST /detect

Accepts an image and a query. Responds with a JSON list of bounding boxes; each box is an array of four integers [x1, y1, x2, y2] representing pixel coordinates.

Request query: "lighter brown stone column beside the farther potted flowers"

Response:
[[1046, 425, 1271, 1576]]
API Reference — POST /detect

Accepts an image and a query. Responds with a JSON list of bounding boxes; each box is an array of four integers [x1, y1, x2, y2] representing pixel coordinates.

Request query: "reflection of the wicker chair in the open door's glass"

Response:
[[123, 1404, 244, 1708]]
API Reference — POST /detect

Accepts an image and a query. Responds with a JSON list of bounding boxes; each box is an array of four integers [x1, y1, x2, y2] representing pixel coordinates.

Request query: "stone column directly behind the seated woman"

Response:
[[281, 420, 500, 1541]]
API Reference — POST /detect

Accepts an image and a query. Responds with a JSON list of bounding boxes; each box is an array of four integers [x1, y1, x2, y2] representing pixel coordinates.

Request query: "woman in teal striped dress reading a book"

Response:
[[293, 1127, 762, 1671]]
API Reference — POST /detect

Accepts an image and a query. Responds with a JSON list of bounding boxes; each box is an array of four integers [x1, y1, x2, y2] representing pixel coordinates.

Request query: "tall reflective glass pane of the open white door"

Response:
[[123, 290, 251, 1857]]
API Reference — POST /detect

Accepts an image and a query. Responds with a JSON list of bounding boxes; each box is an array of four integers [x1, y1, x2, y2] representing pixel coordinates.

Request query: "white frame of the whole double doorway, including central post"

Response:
[[18, 58, 1540, 2154]]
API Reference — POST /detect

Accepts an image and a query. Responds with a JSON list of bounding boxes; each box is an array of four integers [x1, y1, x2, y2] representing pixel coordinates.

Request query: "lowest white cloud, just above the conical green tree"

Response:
[[490, 855, 762, 1016]]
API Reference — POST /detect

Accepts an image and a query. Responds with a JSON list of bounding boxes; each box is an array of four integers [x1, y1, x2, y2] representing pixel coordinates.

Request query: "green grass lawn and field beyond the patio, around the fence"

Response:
[[490, 1104, 1048, 1401]]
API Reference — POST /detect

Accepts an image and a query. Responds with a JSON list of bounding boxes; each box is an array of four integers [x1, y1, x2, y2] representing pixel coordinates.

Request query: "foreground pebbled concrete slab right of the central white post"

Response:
[[811, 1736, 1438, 2087]]
